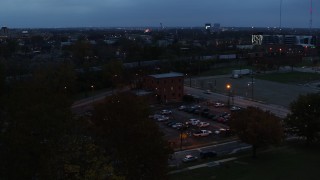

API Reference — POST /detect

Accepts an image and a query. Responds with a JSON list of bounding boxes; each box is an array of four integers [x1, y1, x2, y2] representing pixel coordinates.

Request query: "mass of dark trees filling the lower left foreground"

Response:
[[0, 61, 170, 179]]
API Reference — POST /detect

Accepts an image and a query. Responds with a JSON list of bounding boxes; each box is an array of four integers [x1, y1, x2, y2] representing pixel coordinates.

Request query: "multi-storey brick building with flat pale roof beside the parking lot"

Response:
[[143, 72, 184, 102]]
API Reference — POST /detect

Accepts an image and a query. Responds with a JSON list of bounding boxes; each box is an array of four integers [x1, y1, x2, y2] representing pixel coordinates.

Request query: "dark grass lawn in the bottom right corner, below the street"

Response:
[[170, 143, 320, 180]]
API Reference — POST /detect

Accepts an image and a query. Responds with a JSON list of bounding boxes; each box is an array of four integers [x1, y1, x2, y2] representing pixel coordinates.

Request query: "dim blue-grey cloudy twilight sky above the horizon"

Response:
[[0, 0, 320, 28]]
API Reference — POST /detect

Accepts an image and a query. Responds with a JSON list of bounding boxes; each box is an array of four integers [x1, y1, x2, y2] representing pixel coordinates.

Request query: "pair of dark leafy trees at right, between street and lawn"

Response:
[[230, 93, 320, 157]]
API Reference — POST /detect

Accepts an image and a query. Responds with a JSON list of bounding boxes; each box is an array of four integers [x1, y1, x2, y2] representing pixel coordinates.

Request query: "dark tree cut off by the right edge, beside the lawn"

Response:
[[285, 93, 320, 144]]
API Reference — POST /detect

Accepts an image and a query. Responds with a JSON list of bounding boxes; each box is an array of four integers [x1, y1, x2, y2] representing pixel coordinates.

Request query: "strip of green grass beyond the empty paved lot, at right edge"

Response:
[[256, 72, 320, 84]]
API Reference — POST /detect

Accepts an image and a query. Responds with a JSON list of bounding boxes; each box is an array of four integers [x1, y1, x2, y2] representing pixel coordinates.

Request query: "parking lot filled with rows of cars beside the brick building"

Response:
[[150, 101, 236, 150]]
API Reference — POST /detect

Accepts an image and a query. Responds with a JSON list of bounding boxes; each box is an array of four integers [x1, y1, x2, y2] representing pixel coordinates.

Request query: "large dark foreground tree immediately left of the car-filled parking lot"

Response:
[[93, 93, 170, 180]]
